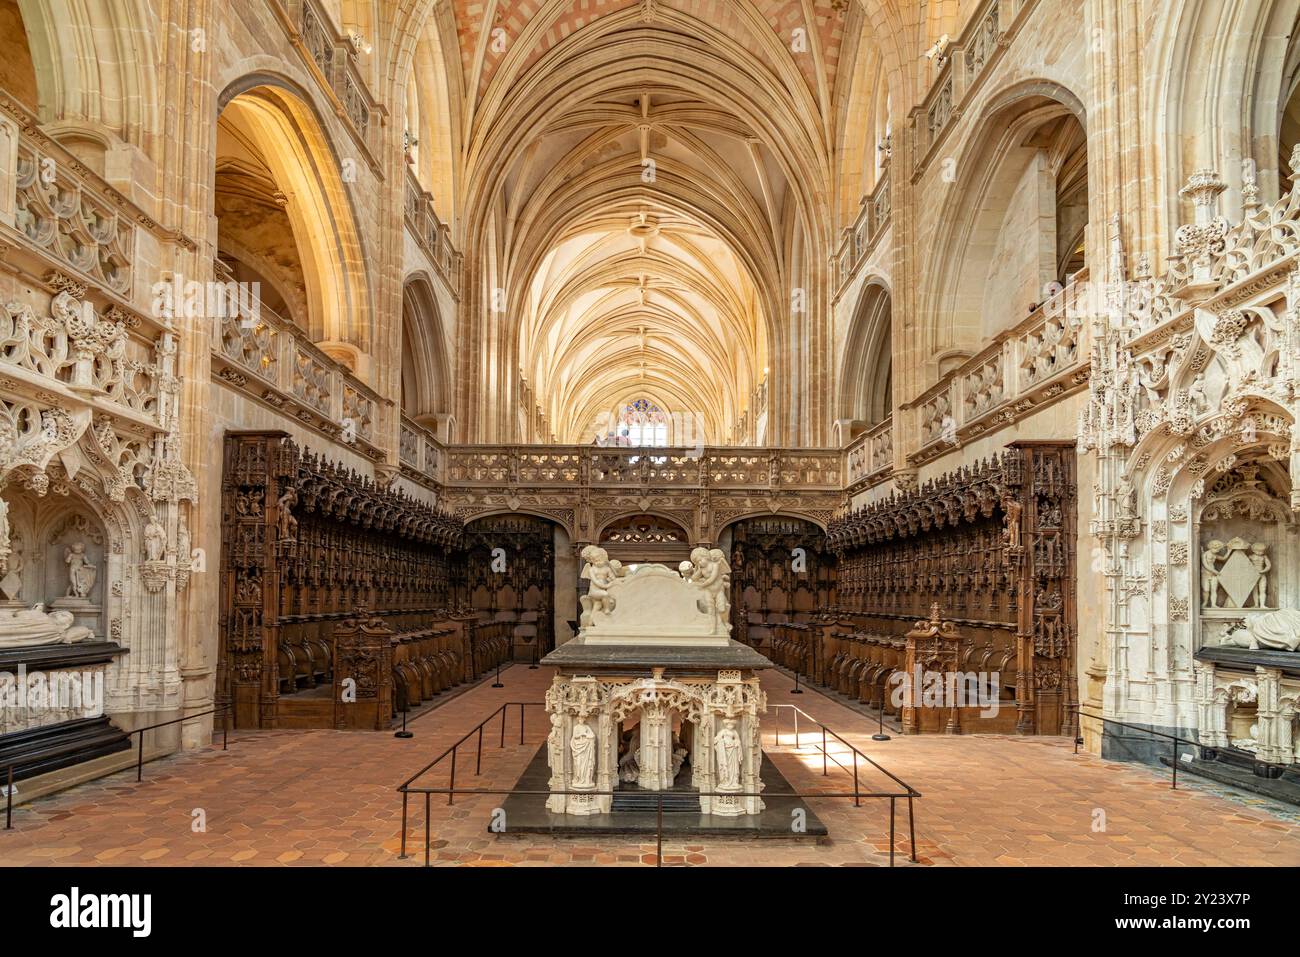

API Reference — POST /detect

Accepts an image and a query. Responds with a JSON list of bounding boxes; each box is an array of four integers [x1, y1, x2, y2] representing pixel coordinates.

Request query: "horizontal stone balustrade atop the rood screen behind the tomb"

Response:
[[442, 445, 844, 490]]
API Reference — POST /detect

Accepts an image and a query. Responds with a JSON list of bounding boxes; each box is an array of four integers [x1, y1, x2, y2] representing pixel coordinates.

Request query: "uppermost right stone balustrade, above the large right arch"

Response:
[[910, 0, 1037, 179]]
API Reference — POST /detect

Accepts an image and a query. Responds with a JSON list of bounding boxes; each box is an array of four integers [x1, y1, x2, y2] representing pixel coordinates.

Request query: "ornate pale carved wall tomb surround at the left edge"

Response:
[[0, 283, 196, 711]]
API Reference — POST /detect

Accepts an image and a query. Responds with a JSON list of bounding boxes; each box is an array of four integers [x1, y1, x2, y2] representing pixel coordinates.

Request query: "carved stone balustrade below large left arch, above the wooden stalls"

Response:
[[212, 261, 389, 459]]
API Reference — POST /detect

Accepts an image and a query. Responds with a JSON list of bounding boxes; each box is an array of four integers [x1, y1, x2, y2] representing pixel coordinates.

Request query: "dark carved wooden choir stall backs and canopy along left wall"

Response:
[[217, 432, 462, 727]]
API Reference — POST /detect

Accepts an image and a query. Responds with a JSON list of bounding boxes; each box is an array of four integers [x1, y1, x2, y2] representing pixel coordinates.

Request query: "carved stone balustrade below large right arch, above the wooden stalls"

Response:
[[909, 269, 1096, 464]]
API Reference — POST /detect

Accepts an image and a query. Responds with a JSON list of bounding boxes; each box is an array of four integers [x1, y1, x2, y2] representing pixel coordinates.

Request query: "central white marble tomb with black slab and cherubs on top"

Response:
[[543, 545, 770, 817]]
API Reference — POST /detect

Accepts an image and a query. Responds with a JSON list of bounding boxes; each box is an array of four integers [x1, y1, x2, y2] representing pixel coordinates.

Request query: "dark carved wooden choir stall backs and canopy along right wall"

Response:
[[818, 442, 1078, 735]]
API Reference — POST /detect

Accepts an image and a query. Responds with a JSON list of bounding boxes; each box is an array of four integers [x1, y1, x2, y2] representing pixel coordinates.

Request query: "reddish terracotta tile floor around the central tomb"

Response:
[[0, 666, 1300, 866]]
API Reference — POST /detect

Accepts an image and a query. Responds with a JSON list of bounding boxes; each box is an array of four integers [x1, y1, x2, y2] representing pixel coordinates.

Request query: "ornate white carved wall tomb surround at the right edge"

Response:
[[1079, 162, 1300, 763]]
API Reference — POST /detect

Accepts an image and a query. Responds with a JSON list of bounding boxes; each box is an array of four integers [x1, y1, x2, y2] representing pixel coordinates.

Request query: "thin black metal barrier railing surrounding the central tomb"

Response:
[[397, 701, 922, 867]]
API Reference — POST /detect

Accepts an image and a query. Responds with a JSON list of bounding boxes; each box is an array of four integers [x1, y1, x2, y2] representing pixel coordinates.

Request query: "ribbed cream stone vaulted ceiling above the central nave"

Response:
[[426, 0, 844, 442]]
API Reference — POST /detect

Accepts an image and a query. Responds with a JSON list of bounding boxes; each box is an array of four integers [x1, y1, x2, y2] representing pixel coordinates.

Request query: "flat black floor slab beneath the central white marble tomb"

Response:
[[488, 744, 828, 840]]
